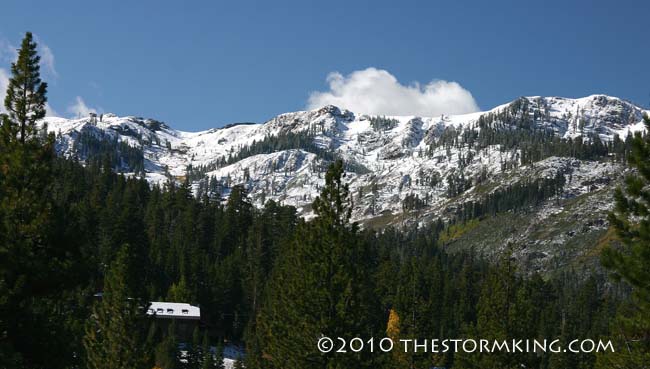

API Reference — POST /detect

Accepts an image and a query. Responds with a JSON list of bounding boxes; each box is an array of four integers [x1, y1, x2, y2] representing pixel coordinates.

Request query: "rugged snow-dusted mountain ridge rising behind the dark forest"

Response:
[[43, 95, 648, 274]]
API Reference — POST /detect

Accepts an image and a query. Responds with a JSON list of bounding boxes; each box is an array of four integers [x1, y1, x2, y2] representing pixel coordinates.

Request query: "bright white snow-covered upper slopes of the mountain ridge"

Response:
[[43, 95, 645, 227]]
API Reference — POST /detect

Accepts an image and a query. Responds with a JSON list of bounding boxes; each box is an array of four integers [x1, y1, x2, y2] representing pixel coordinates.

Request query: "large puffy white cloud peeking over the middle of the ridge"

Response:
[[307, 68, 479, 117]]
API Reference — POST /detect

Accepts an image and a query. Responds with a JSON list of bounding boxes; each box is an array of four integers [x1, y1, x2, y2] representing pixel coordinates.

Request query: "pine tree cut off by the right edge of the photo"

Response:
[[598, 116, 650, 368]]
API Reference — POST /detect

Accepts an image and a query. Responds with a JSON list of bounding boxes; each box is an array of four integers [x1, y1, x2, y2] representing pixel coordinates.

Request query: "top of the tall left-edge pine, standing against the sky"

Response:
[[4, 32, 47, 144]]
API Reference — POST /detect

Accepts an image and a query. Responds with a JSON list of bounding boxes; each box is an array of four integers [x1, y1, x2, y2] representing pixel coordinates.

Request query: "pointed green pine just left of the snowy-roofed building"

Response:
[[84, 245, 149, 369]]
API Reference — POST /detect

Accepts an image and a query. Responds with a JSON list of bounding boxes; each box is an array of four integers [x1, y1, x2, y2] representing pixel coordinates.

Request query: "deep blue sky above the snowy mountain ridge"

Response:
[[0, 0, 650, 130]]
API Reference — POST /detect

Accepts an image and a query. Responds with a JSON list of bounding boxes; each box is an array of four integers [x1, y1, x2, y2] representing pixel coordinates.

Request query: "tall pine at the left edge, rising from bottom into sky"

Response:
[[0, 29, 79, 367]]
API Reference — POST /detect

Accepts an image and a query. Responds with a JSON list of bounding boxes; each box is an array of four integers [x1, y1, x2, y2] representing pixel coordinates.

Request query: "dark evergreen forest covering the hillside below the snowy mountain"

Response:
[[3, 147, 626, 368]]
